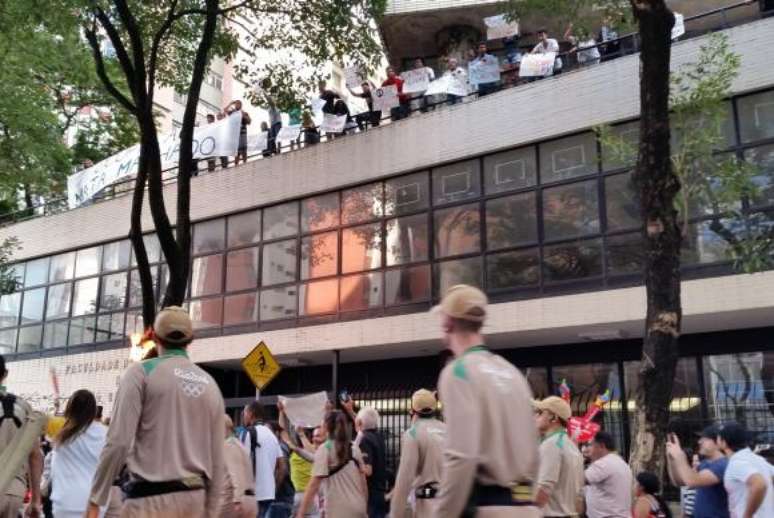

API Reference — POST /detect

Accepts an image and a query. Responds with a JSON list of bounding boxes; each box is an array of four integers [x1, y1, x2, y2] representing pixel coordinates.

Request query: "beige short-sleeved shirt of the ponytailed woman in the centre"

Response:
[[312, 441, 368, 518]]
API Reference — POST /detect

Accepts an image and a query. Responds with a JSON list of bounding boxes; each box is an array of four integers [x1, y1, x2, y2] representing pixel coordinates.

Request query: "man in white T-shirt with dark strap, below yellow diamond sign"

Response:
[[239, 401, 284, 518]]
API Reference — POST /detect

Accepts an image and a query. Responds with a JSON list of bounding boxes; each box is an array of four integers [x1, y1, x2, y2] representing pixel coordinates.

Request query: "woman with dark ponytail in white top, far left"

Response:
[[51, 390, 107, 518]]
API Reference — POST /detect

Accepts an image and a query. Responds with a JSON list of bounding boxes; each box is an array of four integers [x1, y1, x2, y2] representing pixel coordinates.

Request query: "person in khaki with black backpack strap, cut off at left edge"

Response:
[[0, 355, 43, 518]]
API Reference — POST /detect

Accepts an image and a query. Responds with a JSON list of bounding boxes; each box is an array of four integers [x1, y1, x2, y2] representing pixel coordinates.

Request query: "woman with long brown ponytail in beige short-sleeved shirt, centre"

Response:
[[296, 410, 368, 518]]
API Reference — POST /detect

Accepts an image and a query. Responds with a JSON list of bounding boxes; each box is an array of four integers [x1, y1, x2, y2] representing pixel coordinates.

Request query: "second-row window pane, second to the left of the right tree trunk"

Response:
[[543, 180, 599, 241]]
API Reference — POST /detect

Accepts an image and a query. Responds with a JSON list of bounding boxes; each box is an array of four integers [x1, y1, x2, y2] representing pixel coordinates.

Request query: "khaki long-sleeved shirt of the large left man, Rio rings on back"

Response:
[[89, 349, 225, 516]]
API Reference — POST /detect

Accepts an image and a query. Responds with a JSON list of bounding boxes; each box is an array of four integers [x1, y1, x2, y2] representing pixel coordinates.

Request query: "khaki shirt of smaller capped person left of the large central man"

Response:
[[390, 418, 446, 518]]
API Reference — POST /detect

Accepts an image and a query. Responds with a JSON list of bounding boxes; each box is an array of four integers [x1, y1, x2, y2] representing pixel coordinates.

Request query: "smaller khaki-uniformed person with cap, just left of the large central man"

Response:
[[390, 389, 446, 518]]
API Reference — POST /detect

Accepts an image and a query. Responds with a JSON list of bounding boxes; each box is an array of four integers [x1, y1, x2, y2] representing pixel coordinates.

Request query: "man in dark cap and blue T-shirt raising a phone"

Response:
[[666, 425, 729, 518]]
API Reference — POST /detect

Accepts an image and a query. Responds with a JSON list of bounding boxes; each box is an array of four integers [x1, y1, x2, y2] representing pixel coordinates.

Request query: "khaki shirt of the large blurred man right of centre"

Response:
[[436, 346, 538, 518]]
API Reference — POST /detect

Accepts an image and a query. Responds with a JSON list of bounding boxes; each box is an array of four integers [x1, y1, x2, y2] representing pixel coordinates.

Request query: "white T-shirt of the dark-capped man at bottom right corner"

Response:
[[723, 448, 774, 518]]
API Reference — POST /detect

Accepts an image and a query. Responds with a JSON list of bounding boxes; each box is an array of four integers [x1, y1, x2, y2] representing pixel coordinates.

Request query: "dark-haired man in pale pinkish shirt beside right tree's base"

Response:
[[585, 432, 633, 518]]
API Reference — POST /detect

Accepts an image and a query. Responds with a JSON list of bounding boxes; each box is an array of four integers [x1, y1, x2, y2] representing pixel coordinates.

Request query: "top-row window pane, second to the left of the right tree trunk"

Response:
[[540, 132, 597, 183]]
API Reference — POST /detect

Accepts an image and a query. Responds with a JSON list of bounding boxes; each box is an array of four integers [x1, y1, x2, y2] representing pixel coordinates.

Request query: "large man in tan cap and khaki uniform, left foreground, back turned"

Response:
[[86, 306, 225, 518]]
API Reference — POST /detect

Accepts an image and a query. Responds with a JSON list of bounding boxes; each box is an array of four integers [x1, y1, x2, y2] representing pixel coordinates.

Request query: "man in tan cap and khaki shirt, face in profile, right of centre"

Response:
[[535, 396, 583, 517]]
